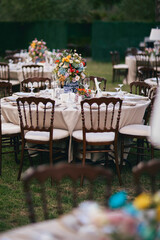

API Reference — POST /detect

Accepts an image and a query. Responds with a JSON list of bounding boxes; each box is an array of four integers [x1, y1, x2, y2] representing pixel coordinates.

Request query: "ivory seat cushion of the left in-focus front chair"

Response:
[[25, 129, 69, 141]]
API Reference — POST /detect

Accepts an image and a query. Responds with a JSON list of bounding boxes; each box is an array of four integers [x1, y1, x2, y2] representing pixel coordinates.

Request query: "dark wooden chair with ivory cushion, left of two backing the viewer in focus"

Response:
[[17, 97, 69, 180]]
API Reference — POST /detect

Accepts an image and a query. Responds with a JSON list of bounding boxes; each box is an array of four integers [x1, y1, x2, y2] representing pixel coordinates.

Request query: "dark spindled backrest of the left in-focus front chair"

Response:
[[17, 97, 55, 140]]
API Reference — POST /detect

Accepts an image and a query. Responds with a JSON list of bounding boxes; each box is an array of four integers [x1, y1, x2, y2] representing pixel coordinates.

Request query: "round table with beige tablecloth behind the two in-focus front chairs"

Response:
[[1, 92, 150, 162]]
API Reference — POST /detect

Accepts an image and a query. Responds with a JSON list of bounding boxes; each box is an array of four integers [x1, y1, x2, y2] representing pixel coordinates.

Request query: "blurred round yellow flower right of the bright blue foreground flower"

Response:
[[133, 193, 152, 209]]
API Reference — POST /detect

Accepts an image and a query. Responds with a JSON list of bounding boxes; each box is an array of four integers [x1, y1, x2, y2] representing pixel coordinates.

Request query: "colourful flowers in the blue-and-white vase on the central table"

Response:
[[53, 50, 86, 86]]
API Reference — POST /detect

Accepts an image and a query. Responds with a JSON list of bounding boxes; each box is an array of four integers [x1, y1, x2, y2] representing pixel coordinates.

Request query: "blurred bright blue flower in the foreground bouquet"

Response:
[[108, 191, 127, 209]]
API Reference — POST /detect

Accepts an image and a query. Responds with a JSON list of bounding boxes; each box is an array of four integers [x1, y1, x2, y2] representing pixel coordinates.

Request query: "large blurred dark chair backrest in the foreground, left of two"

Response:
[[22, 163, 113, 222]]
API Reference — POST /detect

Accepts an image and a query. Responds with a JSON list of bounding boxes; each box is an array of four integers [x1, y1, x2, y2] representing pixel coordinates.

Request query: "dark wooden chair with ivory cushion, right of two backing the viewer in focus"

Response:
[[72, 97, 122, 185]]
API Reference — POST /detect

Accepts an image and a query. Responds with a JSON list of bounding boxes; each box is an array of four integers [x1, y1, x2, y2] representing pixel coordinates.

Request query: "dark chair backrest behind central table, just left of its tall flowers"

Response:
[[21, 77, 51, 92]]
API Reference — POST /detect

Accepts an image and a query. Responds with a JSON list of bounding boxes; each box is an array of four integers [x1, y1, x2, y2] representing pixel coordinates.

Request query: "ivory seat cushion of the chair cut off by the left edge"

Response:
[[1, 122, 21, 135]]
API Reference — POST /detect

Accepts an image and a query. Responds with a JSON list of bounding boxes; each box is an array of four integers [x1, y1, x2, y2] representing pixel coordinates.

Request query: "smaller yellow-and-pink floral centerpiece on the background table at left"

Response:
[[29, 38, 47, 62]]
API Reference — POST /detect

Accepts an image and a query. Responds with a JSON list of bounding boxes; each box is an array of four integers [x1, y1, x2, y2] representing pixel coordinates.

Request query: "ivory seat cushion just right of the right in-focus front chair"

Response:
[[119, 124, 151, 137]]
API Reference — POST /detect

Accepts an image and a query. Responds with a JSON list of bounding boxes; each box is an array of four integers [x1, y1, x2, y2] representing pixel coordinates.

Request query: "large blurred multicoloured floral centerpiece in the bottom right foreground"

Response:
[[67, 191, 160, 240]]
